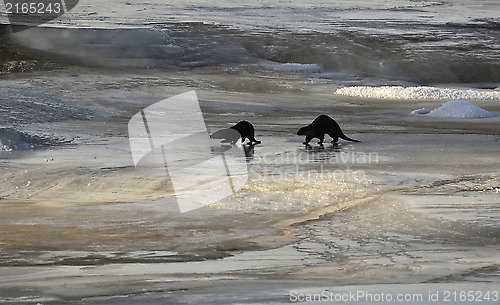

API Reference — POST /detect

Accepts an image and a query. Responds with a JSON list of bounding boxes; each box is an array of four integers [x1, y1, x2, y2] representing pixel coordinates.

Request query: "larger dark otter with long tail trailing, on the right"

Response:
[[297, 114, 361, 145]]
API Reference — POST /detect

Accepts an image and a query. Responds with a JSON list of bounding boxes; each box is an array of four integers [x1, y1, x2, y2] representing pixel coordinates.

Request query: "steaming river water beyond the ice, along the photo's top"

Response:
[[0, 1, 500, 84]]
